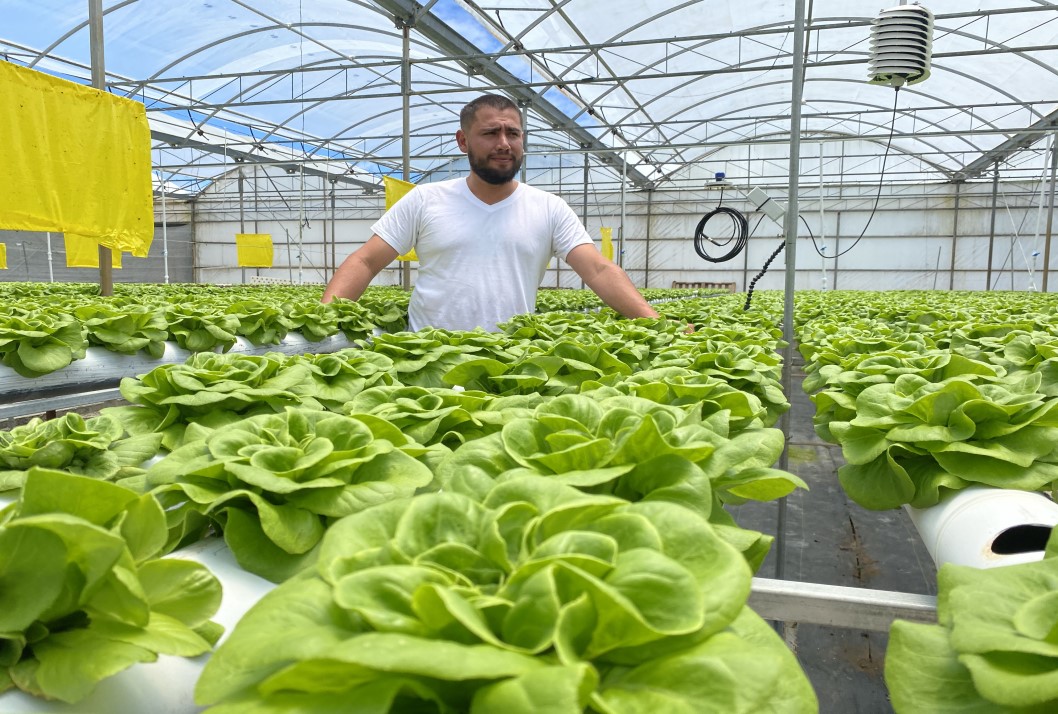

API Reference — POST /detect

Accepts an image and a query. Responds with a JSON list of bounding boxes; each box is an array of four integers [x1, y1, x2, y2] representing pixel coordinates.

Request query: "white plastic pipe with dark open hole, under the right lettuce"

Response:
[[906, 487, 1058, 568]]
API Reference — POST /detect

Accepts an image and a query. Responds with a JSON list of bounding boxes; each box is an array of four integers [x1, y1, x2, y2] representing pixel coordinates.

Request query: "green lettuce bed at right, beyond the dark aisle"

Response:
[[796, 292, 1058, 714]]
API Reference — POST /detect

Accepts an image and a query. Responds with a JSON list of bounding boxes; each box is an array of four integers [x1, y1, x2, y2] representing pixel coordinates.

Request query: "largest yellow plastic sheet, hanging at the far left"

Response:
[[0, 61, 154, 258]]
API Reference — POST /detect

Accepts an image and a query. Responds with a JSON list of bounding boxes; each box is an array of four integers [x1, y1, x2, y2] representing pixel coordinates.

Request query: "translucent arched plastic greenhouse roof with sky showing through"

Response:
[[0, 0, 1058, 194]]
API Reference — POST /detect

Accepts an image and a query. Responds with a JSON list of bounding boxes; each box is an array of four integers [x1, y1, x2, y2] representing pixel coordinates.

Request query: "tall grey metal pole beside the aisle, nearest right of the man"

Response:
[[776, 0, 804, 580]]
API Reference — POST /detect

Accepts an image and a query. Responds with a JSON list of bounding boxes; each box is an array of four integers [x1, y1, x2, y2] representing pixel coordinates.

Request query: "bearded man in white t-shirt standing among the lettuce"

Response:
[[323, 94, 658, 330]]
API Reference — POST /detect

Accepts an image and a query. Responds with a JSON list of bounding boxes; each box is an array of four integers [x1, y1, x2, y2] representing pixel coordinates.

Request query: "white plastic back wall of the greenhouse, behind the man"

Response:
[[156, 174, 1046, 291]]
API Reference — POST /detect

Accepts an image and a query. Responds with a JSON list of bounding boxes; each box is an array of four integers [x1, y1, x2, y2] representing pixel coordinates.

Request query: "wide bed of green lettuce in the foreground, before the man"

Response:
[[0, 300, 817, 714]]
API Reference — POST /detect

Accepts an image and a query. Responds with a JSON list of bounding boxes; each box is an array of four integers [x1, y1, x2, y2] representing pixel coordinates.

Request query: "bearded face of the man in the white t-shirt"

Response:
[[456, 107, 523, 186]]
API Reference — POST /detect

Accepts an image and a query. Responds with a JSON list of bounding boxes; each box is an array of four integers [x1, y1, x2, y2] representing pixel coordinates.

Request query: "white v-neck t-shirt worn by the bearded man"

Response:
[[371, 179, 591, 331]]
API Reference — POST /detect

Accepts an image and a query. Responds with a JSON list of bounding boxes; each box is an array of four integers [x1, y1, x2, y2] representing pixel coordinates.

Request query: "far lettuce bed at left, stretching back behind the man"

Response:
[[0, 282, 715, 378]]
